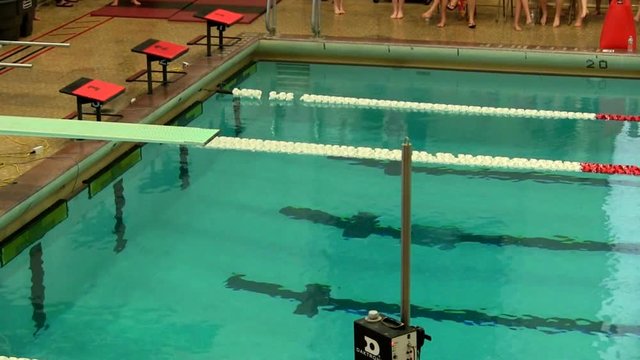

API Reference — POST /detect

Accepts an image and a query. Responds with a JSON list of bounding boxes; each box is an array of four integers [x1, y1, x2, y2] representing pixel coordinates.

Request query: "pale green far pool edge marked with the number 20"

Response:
[[254, 39, 640, 78]]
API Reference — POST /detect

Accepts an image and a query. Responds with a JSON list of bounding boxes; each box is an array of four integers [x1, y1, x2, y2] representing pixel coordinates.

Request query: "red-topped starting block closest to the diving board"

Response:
[[60, 78, 125, 121]]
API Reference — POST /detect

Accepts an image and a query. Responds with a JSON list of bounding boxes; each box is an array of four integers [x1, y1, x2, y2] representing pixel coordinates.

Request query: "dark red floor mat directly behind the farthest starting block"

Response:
[[169, 0, 267, 24]]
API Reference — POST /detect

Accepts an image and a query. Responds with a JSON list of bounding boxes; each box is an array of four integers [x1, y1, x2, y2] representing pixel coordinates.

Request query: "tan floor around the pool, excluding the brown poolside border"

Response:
[[0, 0, 632, 236]]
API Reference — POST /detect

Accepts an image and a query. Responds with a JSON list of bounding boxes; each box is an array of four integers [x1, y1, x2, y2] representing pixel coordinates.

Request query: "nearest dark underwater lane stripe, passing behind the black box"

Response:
[[226, 275, 640, 336]]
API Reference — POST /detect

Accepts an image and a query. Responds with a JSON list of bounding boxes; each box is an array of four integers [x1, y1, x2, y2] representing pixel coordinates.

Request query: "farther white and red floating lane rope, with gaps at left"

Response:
[[232, 88, 640, 121]]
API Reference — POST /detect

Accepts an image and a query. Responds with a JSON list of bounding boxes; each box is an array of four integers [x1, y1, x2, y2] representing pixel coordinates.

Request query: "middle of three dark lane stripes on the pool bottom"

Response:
[[280, 206, 640, 255]]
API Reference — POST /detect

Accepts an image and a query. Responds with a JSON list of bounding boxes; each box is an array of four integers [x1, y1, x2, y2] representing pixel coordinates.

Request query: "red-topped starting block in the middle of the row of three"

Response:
[[126, 39, 189, 94]]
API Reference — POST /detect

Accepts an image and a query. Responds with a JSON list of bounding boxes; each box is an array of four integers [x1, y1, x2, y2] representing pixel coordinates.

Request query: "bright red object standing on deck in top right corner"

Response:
[[600, 0, 637, 52]]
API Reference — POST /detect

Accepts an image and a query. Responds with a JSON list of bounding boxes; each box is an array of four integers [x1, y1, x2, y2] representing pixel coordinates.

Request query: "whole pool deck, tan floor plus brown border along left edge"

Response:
[[0, 0, 635, 241]]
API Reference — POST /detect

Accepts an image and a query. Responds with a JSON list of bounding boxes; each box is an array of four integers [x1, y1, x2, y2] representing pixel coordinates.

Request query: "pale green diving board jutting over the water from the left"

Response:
[[0, 115, 219, 146]]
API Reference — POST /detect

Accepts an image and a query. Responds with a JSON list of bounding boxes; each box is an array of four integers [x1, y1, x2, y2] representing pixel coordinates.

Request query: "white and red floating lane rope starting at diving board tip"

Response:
[[205, 136, 640, 176]]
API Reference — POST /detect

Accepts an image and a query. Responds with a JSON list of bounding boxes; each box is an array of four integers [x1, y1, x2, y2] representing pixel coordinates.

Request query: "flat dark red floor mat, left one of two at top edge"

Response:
[[91, 0, 194, 19]]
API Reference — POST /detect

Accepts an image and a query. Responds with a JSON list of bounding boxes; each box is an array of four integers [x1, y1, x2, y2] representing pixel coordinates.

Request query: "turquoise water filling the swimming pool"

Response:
[[0, 63, 640, 359]]
